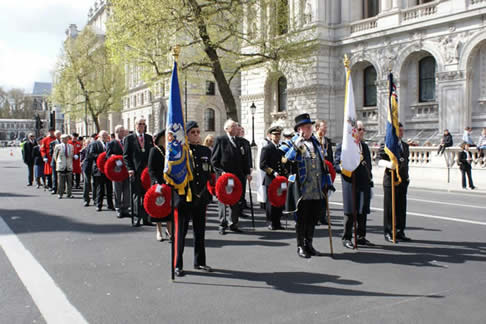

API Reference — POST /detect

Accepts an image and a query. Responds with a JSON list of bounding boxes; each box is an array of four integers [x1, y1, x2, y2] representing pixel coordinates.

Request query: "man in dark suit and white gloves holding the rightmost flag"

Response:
[[379, 123, 411, 242]]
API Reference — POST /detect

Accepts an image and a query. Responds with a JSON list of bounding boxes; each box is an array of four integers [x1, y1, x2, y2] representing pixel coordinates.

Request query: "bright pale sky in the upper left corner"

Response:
[[0, 0, 94, 92]]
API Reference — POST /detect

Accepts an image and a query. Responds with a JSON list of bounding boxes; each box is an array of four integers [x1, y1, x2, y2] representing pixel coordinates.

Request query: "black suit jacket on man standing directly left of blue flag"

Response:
[[123, 133, 154, 175]]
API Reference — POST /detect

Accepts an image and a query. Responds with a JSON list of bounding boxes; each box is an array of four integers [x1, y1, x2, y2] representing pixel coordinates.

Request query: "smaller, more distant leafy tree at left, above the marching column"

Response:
[[52, 26, 125, 132]]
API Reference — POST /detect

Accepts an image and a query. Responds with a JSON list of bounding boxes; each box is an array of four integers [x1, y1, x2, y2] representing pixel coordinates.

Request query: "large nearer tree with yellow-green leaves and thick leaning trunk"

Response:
[[107, 0, 316, 120]]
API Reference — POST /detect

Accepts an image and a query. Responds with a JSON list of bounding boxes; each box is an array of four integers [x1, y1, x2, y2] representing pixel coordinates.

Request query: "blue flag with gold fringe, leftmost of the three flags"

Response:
[[164, 62, 192, 197]]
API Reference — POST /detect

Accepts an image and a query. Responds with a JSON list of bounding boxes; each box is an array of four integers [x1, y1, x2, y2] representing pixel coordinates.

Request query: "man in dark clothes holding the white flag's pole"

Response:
[[334, 121, 374, 249]]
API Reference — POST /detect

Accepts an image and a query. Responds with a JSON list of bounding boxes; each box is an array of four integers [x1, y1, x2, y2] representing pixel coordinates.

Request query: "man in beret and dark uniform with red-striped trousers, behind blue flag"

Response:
[[175, 121, 213, 277]]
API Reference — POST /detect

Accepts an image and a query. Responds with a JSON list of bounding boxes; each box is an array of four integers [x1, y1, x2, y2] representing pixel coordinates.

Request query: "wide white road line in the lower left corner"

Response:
[[0, 216, 88, 324]]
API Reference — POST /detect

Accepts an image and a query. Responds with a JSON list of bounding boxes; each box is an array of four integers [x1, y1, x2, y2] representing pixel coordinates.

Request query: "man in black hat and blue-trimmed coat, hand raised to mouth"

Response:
[[280, 114, 331, 258]]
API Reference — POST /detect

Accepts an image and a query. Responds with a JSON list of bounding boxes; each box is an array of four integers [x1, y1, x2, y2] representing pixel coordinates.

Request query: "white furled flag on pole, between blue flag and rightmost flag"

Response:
[[341, 55, 361, 177]]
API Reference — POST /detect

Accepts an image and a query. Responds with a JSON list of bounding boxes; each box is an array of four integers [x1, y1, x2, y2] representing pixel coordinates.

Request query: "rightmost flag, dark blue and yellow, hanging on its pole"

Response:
[[385, 73, 402, 184]]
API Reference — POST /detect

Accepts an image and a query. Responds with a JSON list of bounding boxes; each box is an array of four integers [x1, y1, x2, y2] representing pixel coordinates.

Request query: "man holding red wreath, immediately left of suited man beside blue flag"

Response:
[[106, 125, 130, 218]]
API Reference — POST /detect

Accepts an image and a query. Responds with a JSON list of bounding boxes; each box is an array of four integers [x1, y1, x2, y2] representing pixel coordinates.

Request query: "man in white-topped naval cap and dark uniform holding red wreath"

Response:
[[260, 126, 285, 230]]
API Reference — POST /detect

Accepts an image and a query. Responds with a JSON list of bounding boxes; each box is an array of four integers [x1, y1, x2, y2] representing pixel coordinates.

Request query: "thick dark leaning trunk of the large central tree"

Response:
[[188, 0, 238, 121]]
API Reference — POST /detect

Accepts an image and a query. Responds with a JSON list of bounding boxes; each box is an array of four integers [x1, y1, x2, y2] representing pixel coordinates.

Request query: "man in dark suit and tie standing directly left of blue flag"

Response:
[[123, 118, 154, 226]]
